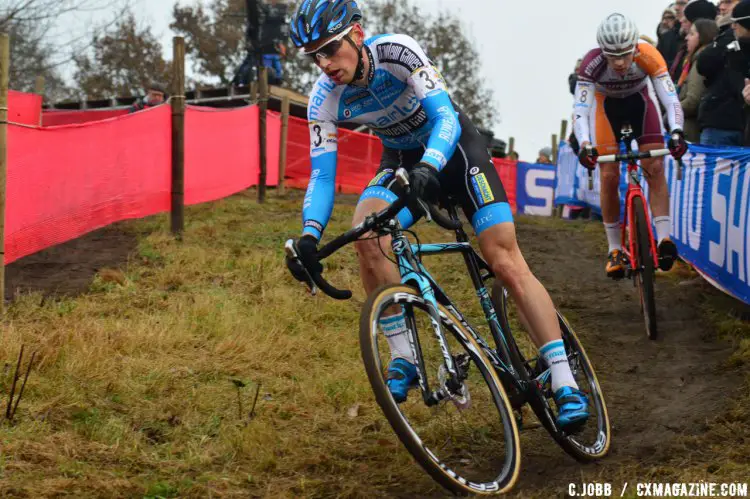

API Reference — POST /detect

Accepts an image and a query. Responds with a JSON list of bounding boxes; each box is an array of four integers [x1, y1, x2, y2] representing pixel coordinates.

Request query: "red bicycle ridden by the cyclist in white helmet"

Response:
[[589, 123, 682, 340]]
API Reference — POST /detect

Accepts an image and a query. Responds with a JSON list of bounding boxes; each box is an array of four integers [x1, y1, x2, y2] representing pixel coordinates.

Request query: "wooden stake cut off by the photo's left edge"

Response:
[[0, 33, 10, 306]]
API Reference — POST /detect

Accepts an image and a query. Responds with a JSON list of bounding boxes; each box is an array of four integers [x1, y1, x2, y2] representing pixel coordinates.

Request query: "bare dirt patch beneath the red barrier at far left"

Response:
[[5, 223, 137, 298]]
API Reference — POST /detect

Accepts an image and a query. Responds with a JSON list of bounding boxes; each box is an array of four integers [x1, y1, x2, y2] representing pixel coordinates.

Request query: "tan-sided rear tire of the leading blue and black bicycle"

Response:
[[492, 289, 612, 462]]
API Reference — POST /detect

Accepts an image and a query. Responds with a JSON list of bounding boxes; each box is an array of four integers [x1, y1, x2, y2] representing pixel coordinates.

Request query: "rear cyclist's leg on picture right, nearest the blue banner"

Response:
[[638, 85, 677, 270]]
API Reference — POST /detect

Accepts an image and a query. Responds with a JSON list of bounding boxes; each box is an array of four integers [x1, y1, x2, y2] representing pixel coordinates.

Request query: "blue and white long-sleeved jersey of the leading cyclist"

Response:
[[302, 35, 461, 239]]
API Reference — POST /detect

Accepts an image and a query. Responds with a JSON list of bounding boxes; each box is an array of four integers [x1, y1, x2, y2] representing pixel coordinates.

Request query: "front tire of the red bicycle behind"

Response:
[[631, 196, 658, 340]]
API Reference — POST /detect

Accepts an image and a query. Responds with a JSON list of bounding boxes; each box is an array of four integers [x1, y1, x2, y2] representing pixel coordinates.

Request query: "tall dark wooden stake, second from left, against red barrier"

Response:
[[171, 36, 185, 239]]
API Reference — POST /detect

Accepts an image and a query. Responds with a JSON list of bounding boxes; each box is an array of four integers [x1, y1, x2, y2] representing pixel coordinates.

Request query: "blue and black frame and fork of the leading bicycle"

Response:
[[390, 207, 529, 405]]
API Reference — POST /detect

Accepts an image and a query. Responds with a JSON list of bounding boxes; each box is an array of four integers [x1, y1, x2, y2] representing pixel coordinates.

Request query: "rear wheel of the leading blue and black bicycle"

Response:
[[492, 288, 612, 462]]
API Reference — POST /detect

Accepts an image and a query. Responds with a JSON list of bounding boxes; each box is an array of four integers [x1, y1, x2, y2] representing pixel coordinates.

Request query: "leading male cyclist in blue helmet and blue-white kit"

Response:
[[287, 0, 589, 429]]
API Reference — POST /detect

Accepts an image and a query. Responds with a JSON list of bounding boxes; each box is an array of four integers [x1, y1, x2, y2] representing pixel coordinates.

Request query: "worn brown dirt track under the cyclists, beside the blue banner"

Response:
[[508, 221, 742, 496]]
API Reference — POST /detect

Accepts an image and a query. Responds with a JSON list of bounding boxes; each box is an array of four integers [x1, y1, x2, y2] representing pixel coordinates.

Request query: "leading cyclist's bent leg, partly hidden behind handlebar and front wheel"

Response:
[[352, 148, 426, 402]]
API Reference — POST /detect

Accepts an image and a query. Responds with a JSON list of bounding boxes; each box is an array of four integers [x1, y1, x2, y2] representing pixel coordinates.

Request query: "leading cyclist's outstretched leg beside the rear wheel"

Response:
[[443, 112, 588, 425]]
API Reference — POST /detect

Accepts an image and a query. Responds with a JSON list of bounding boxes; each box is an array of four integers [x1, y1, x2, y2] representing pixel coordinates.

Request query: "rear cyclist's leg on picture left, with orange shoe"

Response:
[[604, 94, 630, 279]]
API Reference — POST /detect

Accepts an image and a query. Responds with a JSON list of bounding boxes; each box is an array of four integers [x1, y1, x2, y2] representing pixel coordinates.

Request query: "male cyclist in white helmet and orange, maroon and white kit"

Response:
[[573, 14, 687, 279]]
